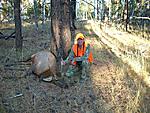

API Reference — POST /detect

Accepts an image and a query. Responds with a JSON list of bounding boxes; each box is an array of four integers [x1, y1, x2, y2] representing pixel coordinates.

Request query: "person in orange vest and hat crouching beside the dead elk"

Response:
[[61, 33, 93, 80]]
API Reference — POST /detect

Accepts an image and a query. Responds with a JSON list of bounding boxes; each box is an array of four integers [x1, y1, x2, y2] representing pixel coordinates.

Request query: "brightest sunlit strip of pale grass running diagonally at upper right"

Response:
[[84, 21, 150, 86]]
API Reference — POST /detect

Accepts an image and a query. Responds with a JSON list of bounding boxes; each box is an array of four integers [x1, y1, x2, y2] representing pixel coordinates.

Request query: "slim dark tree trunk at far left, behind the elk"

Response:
[[14, 0, 22, 51]]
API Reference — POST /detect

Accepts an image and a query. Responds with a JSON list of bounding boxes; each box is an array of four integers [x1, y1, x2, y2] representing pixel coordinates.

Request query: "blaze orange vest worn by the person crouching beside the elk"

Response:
[[72, 43, 93, 64]]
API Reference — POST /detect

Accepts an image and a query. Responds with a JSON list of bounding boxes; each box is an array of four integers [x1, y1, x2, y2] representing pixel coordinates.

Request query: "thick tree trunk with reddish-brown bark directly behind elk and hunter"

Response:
[[50, 0, 71, 71]]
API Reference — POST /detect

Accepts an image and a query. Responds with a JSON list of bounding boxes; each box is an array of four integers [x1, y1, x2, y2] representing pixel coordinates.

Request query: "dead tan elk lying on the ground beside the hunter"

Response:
[[25, 51, 57, 81]]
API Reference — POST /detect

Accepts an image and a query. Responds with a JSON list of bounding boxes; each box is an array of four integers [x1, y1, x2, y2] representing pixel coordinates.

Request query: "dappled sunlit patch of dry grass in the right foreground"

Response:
[[92, 53, 147, 113]]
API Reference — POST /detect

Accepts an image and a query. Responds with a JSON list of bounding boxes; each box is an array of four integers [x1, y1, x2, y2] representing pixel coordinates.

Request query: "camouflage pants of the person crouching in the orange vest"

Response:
[[66, 61, 90, 79]]
